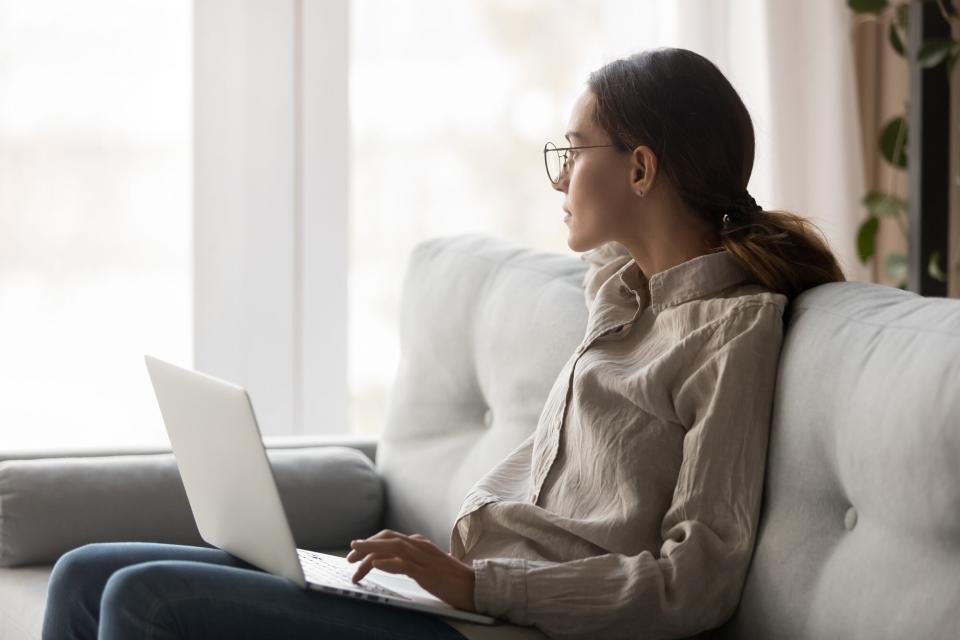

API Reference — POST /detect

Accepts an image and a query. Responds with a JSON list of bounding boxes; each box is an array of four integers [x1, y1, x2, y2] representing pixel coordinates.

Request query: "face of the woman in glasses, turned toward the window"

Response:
[[553, 89, 637, 252]]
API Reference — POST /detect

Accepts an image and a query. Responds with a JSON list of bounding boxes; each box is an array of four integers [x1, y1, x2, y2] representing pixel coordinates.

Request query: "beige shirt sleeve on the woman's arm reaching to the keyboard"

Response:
[[473, 304, 783, 639]]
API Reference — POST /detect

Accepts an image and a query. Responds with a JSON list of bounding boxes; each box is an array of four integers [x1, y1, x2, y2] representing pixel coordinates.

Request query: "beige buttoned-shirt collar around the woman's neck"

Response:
[[618, 249, 752, 312]]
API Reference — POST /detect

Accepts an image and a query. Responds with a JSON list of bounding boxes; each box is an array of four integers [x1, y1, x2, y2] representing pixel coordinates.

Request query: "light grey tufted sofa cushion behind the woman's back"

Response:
[[727, 282, 960, 640]]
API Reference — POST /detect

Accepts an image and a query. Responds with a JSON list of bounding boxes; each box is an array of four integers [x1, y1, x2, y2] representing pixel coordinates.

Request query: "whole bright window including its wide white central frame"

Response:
[[0, 0, 780, 449]]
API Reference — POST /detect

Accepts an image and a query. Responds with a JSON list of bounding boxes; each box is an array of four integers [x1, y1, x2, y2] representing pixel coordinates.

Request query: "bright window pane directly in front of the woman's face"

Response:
[[349, 0, 675, 433]]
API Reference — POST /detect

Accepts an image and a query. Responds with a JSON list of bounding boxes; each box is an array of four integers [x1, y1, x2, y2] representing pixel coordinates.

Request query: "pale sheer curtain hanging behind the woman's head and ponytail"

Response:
[[662, 0, 872, 281]]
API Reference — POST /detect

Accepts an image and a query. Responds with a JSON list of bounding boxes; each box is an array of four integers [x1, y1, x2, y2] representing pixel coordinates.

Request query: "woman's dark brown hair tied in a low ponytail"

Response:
[[587, 48, 846, 300]]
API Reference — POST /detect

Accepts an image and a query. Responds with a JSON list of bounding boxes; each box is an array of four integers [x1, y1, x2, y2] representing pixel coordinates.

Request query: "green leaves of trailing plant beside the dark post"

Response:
[[847, 0, 960, 289]]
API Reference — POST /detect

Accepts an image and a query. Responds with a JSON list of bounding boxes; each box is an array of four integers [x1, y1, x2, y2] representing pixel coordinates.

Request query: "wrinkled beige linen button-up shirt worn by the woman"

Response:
[[442, 243, 787, 639]]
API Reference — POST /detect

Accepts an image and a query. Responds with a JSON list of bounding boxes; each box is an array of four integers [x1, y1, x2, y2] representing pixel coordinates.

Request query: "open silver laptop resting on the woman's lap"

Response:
[[145, 356, 497, 624]]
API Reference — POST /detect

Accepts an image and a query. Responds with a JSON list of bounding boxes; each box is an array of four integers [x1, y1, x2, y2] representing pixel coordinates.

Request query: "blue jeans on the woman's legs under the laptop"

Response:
[[43, 542, 464, 640]]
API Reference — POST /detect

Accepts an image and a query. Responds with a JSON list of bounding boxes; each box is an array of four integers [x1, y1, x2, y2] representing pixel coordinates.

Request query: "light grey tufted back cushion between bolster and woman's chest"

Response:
[[377, 235, 587, 547]]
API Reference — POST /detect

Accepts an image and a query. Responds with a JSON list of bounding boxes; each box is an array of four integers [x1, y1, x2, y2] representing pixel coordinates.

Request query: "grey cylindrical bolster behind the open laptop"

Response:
[[0, 446, 384, 567]]
